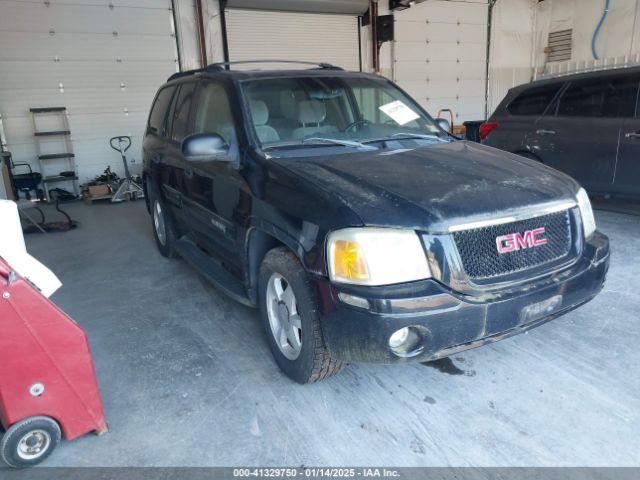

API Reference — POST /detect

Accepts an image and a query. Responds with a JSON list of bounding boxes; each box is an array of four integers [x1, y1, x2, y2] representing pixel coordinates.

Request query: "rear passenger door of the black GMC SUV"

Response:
[[162, 82, 196, 228]]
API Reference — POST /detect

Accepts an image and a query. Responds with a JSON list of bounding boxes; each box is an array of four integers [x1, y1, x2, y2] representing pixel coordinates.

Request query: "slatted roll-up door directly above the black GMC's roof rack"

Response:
[[226, 9, 360, 70]]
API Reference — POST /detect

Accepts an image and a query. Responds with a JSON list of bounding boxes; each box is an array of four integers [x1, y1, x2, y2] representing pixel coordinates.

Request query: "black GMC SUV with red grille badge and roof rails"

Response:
[[143, 64, 609, 383]]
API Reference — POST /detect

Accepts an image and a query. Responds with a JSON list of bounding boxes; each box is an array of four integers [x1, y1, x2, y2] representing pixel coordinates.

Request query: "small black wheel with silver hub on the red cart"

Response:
[[0, 417, 61, 468]]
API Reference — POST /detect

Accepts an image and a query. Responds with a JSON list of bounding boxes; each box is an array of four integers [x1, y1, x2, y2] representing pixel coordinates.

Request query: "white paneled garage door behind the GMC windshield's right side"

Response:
[[393, 0, 488, 123]]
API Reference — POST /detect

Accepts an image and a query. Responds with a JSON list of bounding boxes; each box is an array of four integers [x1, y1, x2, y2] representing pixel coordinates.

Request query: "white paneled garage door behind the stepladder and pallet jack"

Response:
[[0, 0, 177, 184]]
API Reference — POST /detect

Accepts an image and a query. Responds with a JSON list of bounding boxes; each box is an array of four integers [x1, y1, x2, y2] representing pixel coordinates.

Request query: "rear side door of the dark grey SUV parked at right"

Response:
[[535, 76, 627, 192]]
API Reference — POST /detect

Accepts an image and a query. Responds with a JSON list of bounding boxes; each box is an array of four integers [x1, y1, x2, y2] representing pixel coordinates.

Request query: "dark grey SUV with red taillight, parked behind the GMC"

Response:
[[480, 67, 640, 198]]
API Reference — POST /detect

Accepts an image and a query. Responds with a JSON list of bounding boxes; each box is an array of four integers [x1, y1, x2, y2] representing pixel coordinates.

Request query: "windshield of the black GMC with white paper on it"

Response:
[[242, 76, 451, 155]]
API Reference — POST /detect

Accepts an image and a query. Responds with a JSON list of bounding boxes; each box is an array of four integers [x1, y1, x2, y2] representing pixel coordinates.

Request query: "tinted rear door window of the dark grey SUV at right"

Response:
[[558, 75, 638, 117]]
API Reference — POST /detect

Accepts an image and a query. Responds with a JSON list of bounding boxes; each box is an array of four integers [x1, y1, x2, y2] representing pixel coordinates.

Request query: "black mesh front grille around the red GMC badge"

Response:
[[453, 210, 571, 280]]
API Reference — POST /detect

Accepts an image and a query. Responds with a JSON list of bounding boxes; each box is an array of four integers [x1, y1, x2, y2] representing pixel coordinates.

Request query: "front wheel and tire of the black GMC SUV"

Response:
[[259, 248, 344, 383]]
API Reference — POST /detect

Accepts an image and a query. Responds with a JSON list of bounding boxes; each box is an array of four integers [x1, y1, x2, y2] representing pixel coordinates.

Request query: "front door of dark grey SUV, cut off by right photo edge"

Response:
[[613, 74, 640, 196]]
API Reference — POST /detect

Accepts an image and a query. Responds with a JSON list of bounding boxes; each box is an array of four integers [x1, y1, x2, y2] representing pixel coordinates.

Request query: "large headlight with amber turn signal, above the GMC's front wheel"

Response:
[[327, 227, 431, 285]]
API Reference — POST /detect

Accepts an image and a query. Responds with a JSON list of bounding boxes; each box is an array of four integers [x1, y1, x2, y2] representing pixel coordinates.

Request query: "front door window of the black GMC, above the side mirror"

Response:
[[194, 83, 235, 143]]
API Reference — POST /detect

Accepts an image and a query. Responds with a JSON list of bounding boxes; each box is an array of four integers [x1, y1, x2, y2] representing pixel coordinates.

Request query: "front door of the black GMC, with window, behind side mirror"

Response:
[[185, 80, 250, 268]]
